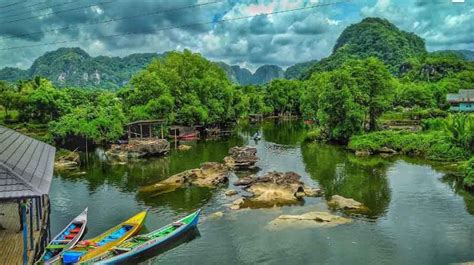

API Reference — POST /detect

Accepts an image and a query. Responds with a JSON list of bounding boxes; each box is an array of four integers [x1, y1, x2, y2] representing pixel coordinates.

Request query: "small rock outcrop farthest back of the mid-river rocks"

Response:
[[224, 146, 258, 169]]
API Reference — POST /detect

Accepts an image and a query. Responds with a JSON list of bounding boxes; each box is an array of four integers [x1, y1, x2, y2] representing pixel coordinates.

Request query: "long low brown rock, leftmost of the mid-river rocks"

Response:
[[140, 162, 229, 195]]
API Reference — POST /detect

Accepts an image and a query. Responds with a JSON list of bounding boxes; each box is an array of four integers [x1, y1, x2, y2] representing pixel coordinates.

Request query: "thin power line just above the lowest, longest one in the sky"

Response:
[[0, 0, 223, 39]]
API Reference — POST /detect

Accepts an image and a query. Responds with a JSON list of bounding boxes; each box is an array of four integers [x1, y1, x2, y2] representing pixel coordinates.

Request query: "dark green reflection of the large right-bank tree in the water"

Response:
[[301, 143, 391, 217]]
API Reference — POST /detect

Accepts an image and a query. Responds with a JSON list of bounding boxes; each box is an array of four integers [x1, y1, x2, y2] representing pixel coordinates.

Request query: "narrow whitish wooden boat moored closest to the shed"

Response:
[[36, 208, 87, 264]]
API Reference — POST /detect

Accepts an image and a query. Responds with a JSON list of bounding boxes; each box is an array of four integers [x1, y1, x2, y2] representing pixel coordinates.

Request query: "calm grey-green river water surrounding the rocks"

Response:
[[51, 122, 474, 264]]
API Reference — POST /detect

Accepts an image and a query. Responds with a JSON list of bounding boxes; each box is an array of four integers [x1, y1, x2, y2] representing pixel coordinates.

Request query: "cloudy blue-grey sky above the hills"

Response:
[[0, 0, 474, 70]]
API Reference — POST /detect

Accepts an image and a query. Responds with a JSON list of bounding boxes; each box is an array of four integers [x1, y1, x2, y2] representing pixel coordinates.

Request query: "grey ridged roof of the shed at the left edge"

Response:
[[0, 126, 56, 199]]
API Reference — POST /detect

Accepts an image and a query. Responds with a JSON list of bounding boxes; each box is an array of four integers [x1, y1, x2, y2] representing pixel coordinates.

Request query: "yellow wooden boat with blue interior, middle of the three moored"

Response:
[[61, 211, 148, 264]]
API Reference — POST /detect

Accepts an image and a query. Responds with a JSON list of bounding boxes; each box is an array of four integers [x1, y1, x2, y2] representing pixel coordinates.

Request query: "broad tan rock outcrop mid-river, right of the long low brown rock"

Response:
[[234, 172, 322, 207]]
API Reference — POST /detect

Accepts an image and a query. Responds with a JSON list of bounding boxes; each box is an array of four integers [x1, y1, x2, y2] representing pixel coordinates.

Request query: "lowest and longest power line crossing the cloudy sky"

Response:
[[0, 0, 352, 51]]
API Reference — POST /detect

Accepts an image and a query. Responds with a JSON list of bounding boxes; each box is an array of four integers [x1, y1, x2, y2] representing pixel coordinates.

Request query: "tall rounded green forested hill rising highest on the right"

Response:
[[303, 18, 427, 78]]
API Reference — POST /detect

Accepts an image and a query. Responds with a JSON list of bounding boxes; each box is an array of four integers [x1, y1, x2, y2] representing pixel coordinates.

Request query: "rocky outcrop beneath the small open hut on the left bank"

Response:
[[106, 139, 170, 161]]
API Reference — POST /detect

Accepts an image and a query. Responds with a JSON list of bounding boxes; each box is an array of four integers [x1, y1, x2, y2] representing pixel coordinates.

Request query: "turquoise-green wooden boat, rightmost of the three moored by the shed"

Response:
[[94, 209, 201, 264]]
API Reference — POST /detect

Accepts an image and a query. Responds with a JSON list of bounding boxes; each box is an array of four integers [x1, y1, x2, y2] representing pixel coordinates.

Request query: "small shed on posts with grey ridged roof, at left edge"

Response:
[[0, 126, 56, 264]]
